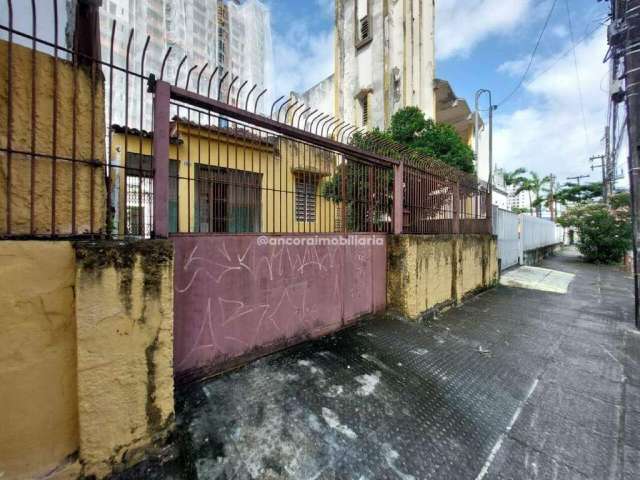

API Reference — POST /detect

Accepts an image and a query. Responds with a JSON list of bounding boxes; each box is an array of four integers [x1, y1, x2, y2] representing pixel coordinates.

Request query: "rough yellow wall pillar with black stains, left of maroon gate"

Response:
[[76, 240, 173, 477]]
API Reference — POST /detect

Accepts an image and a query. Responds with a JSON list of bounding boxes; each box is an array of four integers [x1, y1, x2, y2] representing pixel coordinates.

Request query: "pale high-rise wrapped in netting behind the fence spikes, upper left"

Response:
[[97, 0, 271, 129]]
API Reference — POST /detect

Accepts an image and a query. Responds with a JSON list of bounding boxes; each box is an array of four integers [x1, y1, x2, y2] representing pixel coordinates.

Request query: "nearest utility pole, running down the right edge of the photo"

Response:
[[609, 0, 640, 328]]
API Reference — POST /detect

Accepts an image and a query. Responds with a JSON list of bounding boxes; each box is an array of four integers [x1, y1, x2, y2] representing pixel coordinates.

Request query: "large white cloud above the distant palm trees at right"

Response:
[[495, 29, 608, 181]]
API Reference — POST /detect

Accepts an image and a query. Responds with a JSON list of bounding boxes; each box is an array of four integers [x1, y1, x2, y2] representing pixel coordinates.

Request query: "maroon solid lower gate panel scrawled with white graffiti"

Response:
[[172, 235, 386, 378]]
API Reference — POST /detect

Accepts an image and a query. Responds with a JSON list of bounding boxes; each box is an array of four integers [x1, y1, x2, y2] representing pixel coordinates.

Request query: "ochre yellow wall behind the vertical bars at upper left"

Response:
[[0, 40, 106, 235]]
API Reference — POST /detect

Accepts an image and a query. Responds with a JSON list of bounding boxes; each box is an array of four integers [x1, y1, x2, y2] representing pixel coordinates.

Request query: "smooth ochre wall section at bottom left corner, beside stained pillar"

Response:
[[0, 241, 79, 479]]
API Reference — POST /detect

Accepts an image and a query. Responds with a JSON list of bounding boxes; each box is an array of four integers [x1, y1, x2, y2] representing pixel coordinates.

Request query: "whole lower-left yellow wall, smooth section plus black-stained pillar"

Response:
[[0, 241, 173, 479]]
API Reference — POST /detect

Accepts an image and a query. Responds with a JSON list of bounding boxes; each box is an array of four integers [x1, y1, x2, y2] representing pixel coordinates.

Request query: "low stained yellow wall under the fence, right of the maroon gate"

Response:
[[387, 235, 498, 318]]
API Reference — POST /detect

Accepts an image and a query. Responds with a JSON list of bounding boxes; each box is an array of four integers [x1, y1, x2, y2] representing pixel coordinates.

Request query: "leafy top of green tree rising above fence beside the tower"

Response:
[[383, 107, 475, 173]]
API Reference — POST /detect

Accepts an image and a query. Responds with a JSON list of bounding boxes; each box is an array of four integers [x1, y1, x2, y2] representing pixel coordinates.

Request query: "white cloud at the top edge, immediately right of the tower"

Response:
[[436, 0, 539, 60]]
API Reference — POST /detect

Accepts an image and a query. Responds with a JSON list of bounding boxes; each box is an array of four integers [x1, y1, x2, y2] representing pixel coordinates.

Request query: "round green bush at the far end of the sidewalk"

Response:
[[558, 194, 632, 263]]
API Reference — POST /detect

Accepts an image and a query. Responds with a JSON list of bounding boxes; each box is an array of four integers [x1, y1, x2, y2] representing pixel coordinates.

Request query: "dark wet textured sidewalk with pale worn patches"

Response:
[[121, 249, 640, 480]]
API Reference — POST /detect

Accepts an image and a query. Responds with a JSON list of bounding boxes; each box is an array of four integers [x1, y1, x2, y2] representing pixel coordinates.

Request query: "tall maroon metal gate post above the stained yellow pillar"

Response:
[[153, 80, 171, 238]]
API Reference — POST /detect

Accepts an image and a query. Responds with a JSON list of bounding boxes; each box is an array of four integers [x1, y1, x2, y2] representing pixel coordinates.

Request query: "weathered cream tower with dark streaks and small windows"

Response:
[[295, 0, 436, 128]]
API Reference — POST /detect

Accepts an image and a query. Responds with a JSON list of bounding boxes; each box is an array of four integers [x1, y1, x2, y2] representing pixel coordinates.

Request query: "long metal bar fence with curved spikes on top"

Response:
[[0, 0, 490, 238]]
